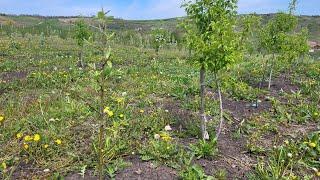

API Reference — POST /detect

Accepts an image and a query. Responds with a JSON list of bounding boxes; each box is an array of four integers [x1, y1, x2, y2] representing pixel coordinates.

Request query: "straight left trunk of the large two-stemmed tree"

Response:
[[200, 65, 209, 140]]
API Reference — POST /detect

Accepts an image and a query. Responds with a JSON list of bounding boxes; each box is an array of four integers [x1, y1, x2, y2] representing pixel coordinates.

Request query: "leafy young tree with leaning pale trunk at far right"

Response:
[[260, 0, 308, 89]]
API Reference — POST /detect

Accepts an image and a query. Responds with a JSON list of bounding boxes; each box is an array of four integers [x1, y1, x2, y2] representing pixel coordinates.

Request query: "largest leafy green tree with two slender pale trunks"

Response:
[[184, 0, 241, 140]]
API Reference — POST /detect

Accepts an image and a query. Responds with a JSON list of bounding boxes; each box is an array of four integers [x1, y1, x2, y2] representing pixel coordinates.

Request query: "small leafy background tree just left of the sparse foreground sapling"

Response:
[[74, 19, 90, 68]]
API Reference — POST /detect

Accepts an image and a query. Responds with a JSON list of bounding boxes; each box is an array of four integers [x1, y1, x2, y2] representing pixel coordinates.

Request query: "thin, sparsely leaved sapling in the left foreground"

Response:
[[73, 9, 114, 180]]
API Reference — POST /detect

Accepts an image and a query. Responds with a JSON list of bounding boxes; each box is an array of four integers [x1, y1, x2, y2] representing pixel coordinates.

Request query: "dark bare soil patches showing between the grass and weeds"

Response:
[[8, 73, 317, 180]]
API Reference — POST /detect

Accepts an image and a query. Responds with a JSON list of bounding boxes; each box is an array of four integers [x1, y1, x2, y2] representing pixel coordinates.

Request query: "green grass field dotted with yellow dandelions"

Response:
[[0, 21, 320, 179]]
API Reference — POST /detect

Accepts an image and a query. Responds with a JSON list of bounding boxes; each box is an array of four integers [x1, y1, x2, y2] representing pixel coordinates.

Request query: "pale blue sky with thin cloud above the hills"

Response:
[[0, 0, 320, 19]]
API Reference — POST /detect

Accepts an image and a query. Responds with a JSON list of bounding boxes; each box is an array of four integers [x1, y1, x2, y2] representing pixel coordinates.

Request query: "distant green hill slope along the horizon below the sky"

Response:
[[0, 14, 320, 42]]
